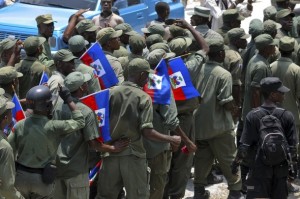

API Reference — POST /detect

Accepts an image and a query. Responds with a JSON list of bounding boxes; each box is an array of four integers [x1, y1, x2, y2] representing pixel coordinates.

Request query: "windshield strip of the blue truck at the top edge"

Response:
[[19, 0, 98, 10]]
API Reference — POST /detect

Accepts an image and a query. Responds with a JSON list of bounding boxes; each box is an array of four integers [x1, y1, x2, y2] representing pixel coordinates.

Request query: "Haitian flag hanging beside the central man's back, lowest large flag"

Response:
[[80, 90, 111, 142]]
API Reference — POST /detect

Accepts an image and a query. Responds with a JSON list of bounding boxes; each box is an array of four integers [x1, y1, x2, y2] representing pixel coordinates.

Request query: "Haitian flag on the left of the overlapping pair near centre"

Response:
[[144, 59, 171, 104]]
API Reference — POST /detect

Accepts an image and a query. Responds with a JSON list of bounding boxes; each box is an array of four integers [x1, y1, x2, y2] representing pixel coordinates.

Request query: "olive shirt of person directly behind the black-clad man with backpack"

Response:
[[242, 54, 272, 119]]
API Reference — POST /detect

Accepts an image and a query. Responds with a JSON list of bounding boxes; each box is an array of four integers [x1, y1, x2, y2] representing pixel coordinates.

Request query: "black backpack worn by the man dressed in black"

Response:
[[256, 108, 289, 166]]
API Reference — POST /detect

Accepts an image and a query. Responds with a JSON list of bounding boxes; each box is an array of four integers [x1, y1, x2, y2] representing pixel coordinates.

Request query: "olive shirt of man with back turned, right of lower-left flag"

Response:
[[109, 81, 153, 158]]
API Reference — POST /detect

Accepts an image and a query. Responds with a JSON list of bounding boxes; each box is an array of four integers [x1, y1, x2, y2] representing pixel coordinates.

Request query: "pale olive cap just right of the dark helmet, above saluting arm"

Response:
[[64, 72, 92, 92]]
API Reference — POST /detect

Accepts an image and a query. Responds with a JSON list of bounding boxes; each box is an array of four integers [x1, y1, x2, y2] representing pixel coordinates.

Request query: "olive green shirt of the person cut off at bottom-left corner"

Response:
[[0, 130, 24, 199]]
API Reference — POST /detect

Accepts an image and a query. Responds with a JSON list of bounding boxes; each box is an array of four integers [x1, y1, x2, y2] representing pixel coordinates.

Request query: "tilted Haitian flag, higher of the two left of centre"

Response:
[[80, 42, 119, 89]]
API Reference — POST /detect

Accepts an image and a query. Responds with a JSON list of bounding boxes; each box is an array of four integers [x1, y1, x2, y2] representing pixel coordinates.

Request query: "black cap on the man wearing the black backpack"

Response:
[[260, 77, 290, 93]]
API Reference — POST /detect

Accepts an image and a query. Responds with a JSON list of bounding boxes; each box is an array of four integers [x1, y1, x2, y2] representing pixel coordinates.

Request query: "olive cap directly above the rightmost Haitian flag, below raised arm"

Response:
[[169, 37, 192, 55]]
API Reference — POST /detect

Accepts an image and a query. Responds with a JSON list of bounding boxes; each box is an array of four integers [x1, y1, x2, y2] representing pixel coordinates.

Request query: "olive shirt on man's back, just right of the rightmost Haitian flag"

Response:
[[194, 60, 234, 140]]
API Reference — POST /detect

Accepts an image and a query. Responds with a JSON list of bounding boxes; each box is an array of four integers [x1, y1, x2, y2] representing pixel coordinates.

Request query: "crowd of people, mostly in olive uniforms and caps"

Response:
[[0, 0, 300, 199]]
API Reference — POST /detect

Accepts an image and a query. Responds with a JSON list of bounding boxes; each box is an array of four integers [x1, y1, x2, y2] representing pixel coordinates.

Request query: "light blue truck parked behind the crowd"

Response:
[[0, 0, 184, 52]]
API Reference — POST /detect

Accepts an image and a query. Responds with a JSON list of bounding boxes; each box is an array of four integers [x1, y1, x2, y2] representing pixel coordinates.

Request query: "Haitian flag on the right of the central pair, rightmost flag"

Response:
[[168, 57, 200, 101]]
